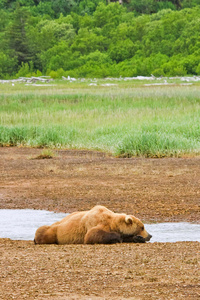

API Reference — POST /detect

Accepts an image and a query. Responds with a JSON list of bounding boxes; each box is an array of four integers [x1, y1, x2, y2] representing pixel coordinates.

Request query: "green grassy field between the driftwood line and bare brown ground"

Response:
[[0, 81, 200, 157]]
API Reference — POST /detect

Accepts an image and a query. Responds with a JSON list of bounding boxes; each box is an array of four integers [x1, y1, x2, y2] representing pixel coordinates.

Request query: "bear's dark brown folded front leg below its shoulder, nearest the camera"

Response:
[[84, 226, 122, 244]]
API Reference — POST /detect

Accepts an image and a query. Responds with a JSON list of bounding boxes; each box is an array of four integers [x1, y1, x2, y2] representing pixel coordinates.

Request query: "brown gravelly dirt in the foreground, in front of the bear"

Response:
[[0, 239, 200, 300]]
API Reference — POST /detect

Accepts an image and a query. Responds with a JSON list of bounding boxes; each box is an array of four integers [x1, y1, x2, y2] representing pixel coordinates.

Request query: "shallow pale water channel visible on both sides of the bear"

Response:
[[0, 209, 200, 243]]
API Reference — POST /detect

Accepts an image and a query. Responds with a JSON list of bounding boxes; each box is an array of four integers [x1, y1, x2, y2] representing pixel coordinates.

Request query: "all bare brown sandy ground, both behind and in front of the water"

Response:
[[0, 148, 200, 300]]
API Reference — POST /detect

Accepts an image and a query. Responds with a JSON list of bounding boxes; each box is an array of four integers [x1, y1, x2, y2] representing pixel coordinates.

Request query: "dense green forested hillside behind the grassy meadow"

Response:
[[0, 0, 200, 78]]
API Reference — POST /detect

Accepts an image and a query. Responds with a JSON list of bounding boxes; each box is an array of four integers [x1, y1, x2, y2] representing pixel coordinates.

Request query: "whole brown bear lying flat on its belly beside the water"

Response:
[[34, 205, 151, 245]]
